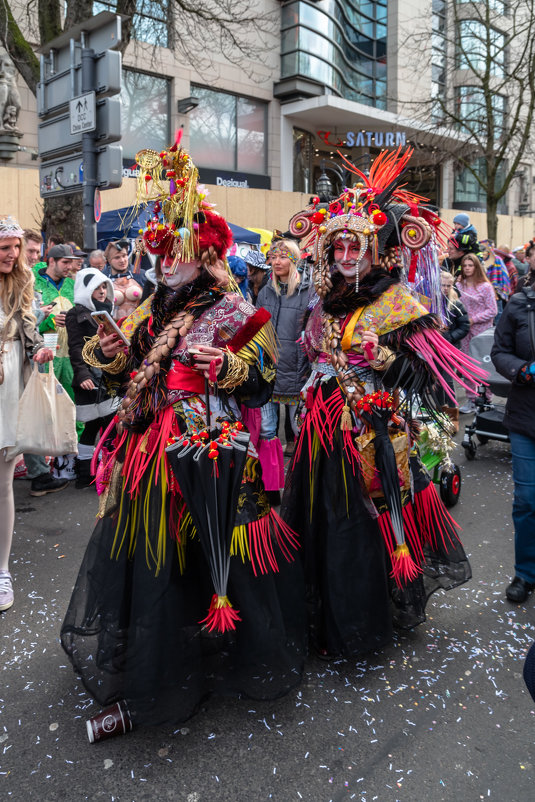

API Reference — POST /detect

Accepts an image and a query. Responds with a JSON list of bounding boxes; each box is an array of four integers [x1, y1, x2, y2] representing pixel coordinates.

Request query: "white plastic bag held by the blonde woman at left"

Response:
[[6, 362, 78, 459]]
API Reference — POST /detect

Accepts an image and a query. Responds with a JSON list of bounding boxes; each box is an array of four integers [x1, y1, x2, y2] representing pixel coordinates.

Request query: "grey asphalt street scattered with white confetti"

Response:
[[0, 432, 535, 802]]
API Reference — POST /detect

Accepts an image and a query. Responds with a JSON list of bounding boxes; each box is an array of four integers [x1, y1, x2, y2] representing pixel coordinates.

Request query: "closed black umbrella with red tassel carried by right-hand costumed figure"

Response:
[[357, 391, 420, 585]]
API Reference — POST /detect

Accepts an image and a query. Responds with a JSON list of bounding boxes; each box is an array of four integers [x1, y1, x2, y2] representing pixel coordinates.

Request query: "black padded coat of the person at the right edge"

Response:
[[490, 289, 535, 440]]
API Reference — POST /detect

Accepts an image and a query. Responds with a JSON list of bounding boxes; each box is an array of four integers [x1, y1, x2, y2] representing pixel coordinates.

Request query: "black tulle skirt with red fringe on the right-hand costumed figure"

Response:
[[281, 385, 471, 657]]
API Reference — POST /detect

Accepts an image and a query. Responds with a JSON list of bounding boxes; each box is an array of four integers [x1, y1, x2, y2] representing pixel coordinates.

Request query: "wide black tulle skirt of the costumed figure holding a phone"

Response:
[[61, 456, 306, 724]]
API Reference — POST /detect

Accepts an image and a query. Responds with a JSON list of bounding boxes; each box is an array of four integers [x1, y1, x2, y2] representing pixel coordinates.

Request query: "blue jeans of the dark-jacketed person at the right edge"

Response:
[[509, 432, 535, 584]]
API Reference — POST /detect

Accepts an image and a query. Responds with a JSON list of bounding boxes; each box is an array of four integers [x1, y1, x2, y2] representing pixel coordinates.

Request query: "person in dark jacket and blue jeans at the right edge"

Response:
[[491, 286, 535, 603]]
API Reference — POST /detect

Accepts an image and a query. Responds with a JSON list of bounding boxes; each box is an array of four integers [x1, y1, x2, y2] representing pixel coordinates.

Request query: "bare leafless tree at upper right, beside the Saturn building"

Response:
[[396, 0, 535, 238]]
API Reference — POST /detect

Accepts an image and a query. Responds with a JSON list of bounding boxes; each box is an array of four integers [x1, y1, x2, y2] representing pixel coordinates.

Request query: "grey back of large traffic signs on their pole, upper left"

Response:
[[37, 11, 128, 238]]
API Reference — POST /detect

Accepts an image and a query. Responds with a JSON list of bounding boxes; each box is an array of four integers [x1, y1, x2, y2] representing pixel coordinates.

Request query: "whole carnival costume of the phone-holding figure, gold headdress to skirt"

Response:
[[61, 136, 306, 724]]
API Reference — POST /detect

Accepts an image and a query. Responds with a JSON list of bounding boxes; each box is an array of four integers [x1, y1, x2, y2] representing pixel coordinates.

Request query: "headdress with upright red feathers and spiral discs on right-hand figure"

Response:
[[289, 148, 448, 297]]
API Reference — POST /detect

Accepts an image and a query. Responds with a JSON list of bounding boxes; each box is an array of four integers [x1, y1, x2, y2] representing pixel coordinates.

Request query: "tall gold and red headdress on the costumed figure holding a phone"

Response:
[[130, 134, 232, 270]]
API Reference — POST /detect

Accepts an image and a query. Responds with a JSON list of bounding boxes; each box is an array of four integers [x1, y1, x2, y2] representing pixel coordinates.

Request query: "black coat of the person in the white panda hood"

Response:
[[65, 304, 114, 406]]
